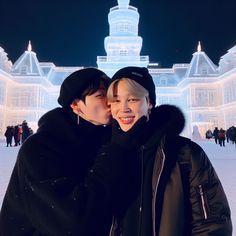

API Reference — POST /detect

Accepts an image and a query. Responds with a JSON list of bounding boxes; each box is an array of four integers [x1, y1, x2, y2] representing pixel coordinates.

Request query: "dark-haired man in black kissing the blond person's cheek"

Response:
[[0, 68, 111, 236]]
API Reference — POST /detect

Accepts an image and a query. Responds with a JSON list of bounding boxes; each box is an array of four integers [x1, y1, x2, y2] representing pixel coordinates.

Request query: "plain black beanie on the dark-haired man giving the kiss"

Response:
[[57, 67, 109, 108]]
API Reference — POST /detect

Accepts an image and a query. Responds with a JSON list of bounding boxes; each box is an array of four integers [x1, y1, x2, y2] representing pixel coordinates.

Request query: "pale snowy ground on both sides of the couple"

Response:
[[0, 137, 236, 233]]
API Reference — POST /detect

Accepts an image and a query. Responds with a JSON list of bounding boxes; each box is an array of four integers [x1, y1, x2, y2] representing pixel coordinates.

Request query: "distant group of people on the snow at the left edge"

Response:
[[4, 120, 33, 147]]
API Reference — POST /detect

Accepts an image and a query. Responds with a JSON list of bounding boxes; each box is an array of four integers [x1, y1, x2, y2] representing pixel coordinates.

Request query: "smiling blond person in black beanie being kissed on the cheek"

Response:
[[103, 67, 232, 236]]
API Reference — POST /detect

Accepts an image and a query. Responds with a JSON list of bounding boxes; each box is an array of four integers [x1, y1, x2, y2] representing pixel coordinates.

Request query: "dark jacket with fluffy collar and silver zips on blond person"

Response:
[[103, 105, 232, 236]]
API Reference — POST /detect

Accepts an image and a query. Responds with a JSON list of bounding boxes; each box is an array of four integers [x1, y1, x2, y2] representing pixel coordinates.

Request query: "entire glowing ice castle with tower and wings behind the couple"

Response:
[[0, 0, 236, 137]]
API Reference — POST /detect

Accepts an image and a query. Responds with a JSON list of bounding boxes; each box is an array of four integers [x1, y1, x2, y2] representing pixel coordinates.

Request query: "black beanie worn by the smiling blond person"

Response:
[[111, 66, 156, 107]]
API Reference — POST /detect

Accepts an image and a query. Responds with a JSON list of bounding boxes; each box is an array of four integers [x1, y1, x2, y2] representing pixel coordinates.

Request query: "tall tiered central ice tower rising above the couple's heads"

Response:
[[97, 0, 149, 76]]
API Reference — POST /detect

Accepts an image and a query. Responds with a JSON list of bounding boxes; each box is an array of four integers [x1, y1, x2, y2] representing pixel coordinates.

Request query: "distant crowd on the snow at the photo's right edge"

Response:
[[206, 126, 236, 147]]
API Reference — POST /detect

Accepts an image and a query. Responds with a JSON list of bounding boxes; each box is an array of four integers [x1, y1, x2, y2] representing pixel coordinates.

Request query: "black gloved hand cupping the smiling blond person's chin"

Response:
[[111, 116, 147, 150]]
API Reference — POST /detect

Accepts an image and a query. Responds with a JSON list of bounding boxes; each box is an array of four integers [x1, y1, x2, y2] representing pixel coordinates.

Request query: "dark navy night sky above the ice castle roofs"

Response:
[[0, 0, 236, 67]]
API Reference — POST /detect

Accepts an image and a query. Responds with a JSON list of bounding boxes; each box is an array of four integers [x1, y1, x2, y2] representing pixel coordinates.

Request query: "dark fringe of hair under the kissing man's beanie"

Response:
[[78, 76, 109, 103]]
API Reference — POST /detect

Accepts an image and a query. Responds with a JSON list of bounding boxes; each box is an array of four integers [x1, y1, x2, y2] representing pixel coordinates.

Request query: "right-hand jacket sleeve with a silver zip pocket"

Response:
[[190, 142, 232, 236]]
